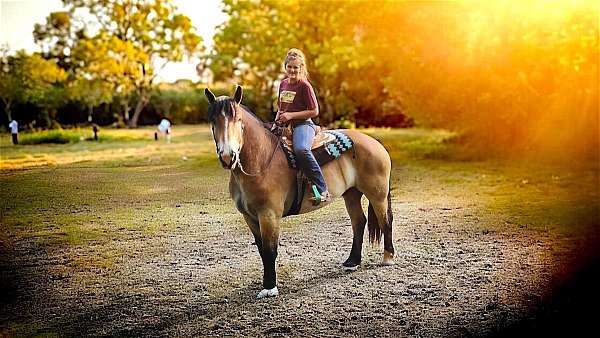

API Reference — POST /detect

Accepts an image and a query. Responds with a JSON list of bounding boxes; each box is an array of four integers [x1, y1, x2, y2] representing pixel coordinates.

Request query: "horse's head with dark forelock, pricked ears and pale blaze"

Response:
[[204, 86, 244, 169]]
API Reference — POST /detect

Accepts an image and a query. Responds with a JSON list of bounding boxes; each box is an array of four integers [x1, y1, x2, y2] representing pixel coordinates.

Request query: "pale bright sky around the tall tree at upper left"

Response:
[[0, 0, 227, 82]]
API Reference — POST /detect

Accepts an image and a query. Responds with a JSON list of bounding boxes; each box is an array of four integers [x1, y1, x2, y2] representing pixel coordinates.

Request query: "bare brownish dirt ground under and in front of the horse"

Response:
[[0, 160, 600, 337]]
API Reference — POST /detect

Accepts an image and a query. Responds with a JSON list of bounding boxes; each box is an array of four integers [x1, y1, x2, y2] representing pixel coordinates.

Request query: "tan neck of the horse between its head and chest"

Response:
[[240, 112, 277, 172]]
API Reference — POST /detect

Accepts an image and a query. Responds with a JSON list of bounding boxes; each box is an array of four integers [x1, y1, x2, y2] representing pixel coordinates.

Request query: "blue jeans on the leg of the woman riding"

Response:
[[293, 123, 327, 193]]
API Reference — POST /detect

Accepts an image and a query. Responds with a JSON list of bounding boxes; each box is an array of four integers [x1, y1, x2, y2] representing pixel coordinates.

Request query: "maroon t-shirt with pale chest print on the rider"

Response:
[[277, 78, 317, 118]]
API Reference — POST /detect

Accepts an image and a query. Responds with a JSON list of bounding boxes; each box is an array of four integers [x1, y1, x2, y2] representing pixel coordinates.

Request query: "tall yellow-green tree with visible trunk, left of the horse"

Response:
[[36, 0, 202, 127]]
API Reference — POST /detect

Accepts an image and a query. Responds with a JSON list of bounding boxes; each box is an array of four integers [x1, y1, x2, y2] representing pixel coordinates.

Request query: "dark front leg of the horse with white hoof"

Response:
[[255, 211, 281, 299]]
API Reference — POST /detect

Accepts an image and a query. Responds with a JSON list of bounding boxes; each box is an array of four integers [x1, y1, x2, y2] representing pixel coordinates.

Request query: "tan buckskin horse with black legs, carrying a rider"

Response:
[[204, 86, 394, 299]]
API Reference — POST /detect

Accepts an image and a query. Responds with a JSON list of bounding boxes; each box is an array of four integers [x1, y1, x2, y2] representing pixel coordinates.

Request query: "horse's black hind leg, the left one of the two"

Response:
[[343, 188, 367, 271]]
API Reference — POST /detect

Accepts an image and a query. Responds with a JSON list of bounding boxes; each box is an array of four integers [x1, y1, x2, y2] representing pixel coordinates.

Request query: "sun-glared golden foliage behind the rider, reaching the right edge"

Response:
[[206, 0, 599, 157]]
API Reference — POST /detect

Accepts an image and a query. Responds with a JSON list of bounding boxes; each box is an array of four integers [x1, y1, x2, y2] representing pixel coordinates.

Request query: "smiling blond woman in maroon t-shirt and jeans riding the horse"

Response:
[[275, 48, 331, 204]]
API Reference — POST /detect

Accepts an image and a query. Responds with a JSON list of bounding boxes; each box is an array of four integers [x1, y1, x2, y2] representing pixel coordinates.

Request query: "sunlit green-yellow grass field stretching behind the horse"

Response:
[[0, 125, 599, 242]]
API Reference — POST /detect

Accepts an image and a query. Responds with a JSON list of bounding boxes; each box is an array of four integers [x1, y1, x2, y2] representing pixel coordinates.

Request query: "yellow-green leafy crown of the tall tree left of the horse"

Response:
[[34, 0, 201, 127]]
